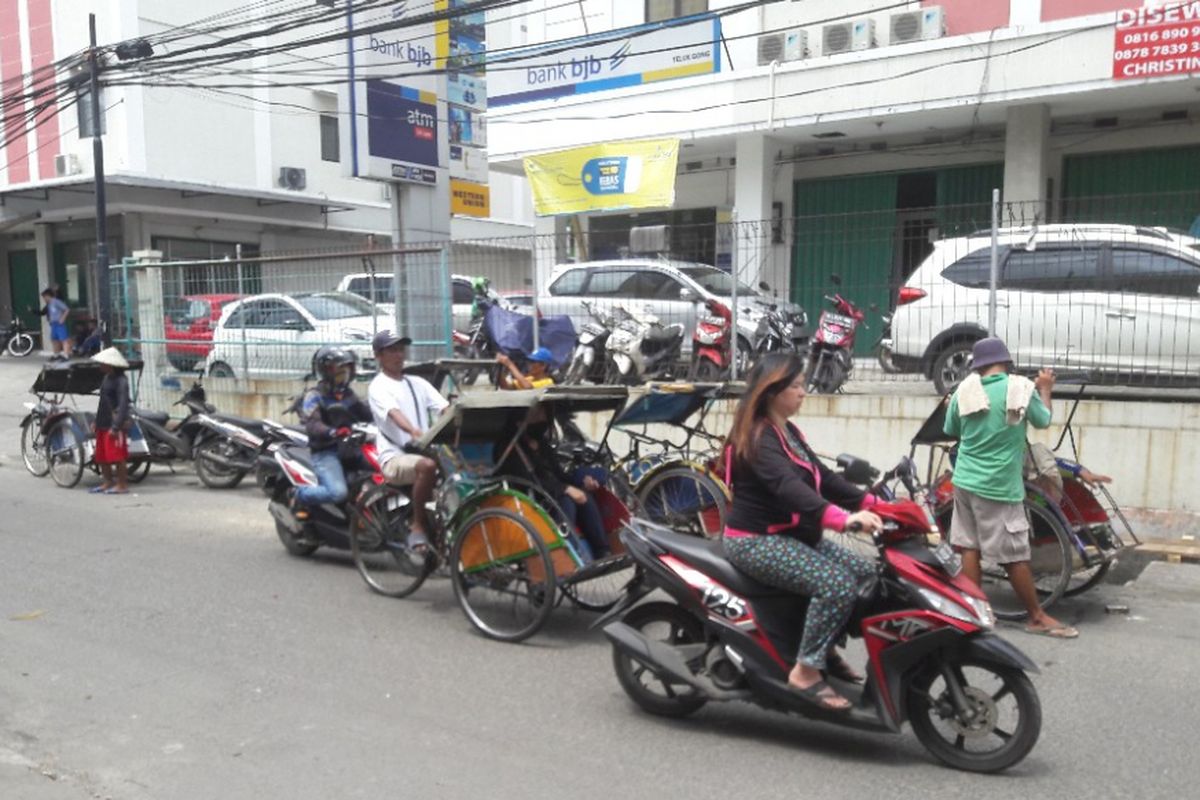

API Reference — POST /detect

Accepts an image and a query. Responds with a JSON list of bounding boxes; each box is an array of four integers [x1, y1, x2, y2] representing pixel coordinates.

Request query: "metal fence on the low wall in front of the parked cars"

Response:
[[113, 190, 1200, 412]]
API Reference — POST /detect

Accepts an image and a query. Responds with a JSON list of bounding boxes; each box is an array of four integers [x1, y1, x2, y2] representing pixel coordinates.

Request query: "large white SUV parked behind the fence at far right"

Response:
[[892, 224, 1200, 392]]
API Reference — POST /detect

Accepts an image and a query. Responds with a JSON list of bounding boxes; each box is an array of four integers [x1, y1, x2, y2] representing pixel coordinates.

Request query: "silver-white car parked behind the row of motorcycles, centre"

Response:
[[538, 259, 808, 357]]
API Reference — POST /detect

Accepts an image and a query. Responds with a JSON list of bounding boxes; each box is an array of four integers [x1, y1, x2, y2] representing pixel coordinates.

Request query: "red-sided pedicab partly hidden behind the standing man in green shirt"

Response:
[[910, 379, 1141, 620]]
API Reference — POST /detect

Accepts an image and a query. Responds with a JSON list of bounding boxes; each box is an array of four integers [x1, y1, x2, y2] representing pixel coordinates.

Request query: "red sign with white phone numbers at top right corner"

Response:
[[1112, 0, 1200, 80]]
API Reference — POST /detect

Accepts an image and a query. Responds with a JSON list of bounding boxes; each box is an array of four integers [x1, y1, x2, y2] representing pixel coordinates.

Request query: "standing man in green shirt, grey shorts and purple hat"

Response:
[[944, 338, 1079, 639]]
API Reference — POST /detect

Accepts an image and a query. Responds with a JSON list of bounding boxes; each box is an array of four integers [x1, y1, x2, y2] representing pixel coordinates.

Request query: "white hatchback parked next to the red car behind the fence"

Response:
[[204, 291, 381, 379]]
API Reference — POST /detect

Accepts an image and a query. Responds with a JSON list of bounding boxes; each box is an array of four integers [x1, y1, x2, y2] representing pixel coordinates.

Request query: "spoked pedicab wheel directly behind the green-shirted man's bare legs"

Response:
[[982, 491, 1073, 620]]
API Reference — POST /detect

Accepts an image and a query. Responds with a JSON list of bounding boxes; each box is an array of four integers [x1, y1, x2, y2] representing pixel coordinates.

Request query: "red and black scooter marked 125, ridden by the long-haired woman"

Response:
[[596, 500, 1042, 772]]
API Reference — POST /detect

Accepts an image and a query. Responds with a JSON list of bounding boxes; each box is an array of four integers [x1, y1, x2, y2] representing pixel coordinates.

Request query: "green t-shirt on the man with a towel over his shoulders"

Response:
[[943, 374, 1050, 503]]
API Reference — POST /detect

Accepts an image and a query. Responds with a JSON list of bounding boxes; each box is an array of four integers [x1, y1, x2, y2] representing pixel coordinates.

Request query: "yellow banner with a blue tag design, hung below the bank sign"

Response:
[[524, 139, 679, 217]]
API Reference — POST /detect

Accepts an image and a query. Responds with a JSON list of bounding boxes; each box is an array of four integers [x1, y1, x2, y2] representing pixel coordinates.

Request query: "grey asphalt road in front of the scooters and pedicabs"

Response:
[[0, 359, 1200, 800]]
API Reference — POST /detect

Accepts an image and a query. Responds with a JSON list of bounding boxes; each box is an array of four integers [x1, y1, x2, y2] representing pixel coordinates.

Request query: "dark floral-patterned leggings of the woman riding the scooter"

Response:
[[725, 535, 875, 669]]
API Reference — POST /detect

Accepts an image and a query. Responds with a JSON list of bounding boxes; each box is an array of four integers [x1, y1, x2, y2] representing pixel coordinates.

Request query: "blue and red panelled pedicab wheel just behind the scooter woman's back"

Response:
[[635, 465, 726, 539]]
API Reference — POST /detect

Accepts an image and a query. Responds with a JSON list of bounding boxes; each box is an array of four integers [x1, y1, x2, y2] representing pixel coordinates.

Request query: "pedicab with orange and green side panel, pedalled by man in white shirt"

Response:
[[352, 386, 631, 642]]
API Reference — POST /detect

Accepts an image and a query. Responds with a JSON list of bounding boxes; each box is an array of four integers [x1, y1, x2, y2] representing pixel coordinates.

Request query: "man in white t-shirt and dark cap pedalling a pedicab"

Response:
[[367, 331, 449, 554]]
